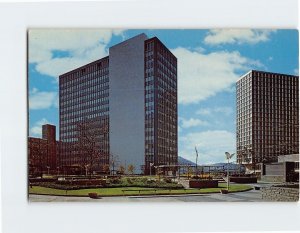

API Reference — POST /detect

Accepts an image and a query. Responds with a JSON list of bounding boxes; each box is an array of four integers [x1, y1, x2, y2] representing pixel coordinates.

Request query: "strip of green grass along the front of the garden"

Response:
[[29, 184, 251, 196]]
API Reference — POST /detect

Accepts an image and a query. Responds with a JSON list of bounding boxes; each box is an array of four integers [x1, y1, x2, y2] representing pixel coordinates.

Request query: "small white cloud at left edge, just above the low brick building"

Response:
[[29, 88, 58, 110]]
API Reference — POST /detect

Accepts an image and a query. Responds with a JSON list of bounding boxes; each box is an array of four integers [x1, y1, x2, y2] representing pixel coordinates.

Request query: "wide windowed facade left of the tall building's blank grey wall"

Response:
[[59, 57, 109, 170]]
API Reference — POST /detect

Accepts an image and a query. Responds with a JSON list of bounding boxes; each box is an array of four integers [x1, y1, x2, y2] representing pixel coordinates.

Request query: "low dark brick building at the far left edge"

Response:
[[28, 124, 59, 175]]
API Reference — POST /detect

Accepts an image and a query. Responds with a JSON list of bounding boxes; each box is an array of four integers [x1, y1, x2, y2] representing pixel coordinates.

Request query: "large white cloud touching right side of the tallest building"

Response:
[[172, 47, 262, 104]]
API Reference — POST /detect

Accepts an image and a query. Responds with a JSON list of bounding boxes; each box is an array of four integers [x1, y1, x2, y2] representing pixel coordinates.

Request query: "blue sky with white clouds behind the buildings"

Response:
[[28, 29, 299, 164]]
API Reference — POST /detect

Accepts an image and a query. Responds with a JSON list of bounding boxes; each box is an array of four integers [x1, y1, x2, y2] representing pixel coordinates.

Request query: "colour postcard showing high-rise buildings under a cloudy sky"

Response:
[[27, 28, 299, 202]]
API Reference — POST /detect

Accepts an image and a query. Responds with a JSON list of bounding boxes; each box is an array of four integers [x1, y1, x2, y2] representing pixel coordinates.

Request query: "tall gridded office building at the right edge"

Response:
[[236, 70, 299, 166]]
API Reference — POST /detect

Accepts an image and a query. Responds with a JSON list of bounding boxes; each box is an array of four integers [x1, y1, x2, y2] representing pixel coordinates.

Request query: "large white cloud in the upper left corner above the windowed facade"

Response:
[[28, 29, 122, 78]]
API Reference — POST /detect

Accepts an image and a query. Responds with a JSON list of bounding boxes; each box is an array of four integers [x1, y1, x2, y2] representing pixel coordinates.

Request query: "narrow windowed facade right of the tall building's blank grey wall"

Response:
[[145, 37, 178, 174]]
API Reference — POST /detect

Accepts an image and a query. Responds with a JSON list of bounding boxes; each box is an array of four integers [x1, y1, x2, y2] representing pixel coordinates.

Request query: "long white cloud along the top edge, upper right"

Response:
[[204, 29, 275, 45]]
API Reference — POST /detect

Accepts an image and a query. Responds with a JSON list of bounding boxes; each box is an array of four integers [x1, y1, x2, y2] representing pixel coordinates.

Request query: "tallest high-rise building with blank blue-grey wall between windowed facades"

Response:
[[59, 34, 178, 173]]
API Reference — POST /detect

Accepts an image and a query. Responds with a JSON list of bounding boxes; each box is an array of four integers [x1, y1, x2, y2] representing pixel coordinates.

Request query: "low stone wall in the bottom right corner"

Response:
[[261, 186, 299, 201]]
